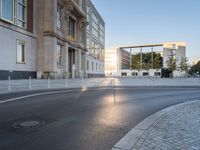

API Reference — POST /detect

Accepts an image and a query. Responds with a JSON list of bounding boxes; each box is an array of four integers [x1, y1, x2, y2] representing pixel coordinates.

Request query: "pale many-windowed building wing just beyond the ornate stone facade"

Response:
[[86, 0, 105, 77]]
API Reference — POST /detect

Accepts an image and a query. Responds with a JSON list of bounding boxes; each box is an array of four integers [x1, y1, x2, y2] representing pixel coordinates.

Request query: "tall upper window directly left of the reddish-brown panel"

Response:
[[17, 0, 26, 28]]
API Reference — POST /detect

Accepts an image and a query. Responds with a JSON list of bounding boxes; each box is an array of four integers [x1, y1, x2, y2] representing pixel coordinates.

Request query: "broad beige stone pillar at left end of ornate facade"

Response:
[[37, 0, 57, 78]]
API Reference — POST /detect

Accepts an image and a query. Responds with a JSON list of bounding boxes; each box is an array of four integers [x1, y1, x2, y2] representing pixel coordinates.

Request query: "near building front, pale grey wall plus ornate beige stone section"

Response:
[[0, 0, 88, 79]]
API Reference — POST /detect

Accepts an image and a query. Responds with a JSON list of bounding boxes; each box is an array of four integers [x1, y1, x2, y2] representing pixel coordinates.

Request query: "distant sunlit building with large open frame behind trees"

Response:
[[105, 42, 186, 76]]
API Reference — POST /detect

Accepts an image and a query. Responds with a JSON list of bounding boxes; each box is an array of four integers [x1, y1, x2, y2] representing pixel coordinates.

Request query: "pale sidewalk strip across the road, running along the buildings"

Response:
[[0, 78, 200, 94]]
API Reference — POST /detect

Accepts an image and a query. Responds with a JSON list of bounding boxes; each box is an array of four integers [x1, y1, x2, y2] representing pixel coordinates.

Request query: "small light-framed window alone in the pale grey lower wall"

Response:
[[17, 41, 26, 63]]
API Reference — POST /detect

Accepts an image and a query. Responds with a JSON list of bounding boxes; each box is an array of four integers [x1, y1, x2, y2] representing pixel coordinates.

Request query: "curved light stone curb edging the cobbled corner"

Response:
[[112, 100, 200, 150]]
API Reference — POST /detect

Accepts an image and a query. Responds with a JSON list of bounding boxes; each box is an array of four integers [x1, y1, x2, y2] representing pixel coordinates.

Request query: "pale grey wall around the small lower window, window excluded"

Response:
[[0, 25, 37, 71]]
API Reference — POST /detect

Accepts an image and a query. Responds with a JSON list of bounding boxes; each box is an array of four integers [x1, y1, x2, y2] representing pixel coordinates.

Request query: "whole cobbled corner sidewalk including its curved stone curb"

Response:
[[112, 101, 200, 150]]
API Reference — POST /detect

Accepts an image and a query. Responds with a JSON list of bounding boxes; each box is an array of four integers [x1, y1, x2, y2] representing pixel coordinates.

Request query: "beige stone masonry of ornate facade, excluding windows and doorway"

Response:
[[36, 0, 86, 77]]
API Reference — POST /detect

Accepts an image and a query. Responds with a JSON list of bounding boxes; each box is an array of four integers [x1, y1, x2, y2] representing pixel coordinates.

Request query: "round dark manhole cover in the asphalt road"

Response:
[[13, 120, 44, 129]]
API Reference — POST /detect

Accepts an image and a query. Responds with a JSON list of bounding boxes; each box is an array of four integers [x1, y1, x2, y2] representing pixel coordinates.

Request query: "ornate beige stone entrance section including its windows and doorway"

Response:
[[37, 0, 87, 78]]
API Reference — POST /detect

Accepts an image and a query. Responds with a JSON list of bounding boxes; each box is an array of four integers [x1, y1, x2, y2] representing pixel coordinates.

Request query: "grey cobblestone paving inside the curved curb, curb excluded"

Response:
[[132, 101, 200, 150]]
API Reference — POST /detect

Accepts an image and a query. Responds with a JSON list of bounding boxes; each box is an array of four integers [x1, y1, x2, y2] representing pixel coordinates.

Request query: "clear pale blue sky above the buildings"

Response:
[[92, 0, 200, 59]]
